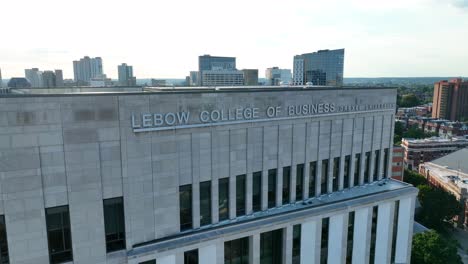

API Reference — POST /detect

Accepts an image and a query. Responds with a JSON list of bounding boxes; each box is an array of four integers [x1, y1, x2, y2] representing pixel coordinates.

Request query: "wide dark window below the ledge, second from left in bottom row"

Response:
[[224, 237, 249, 264]]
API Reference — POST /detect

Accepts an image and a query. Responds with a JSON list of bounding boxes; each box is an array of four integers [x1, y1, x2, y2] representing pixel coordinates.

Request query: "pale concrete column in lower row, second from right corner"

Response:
[[374, 202, 395, 263]]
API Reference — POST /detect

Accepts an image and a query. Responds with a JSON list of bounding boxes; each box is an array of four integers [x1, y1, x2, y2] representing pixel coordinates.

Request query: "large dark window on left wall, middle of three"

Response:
[[45, 205, 73, 263]]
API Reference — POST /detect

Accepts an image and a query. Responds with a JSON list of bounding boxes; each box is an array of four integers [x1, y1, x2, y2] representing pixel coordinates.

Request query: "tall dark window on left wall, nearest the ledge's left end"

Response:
[[104, 197, 125, 253]]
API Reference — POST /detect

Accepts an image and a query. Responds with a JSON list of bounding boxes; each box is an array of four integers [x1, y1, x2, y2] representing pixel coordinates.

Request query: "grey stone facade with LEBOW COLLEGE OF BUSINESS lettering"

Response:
[[0, 87, 417, 264]]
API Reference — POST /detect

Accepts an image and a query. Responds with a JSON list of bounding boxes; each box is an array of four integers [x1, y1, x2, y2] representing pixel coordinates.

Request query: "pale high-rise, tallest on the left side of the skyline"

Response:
[[73, 56, 103, 83]]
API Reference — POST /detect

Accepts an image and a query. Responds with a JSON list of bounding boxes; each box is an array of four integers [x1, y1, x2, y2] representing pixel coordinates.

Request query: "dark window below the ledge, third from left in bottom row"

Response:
[[260, 229, 283, 264]]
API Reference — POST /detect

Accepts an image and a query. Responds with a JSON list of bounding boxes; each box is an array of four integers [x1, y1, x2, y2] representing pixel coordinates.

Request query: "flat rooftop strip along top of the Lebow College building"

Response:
[[0, 85, 396, 98]]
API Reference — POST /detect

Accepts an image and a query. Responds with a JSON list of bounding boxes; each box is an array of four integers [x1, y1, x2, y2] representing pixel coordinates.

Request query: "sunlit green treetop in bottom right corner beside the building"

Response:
[[411, 230, 463, 264]]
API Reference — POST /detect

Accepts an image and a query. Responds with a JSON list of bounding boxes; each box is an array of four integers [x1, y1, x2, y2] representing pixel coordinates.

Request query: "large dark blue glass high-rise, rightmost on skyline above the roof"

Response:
[[293, 49, 344, 86]]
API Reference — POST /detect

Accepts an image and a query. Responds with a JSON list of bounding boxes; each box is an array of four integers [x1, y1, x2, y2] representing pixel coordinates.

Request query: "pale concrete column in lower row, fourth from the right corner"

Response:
[[328, 213, 348, 264]]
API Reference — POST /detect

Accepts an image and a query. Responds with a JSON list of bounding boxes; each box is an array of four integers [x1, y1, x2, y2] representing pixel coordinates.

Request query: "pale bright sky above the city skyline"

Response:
[[0, 0, 468, 79]]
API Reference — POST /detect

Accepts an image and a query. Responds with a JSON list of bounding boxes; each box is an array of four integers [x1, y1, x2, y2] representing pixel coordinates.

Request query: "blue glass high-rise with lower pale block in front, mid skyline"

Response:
[[198, 55, 244, 86]]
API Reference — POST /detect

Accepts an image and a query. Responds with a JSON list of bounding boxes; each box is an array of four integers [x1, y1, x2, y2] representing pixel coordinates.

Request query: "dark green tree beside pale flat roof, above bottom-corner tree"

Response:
[[416, 185, 462, 231]]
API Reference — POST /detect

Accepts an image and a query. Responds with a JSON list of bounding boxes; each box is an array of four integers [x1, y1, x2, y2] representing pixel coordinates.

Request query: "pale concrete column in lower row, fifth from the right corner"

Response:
[[301, 219, 322, 263]]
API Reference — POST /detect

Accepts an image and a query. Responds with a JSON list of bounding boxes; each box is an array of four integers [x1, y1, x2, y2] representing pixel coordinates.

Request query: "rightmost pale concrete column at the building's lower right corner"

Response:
[[395, 197, 415, 263]]
